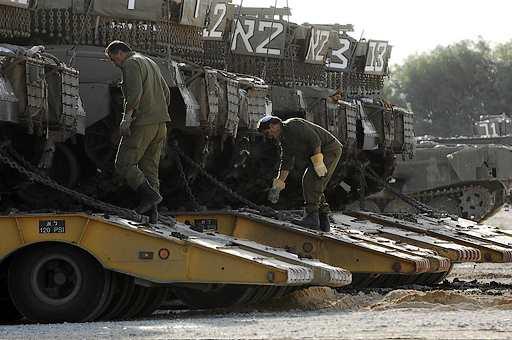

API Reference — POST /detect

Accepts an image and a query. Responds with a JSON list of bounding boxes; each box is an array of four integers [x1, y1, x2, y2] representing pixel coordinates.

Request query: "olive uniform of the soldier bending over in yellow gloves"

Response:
[[280, 118, 343, 213]]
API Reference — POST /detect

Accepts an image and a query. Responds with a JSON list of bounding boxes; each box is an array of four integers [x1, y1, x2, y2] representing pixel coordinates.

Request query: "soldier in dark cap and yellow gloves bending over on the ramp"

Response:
[[258, 116, 343, 231]]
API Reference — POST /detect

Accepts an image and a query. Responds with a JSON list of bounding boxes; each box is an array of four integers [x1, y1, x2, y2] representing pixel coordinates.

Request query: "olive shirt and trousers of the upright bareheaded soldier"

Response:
[[115, 52, 171, 191]]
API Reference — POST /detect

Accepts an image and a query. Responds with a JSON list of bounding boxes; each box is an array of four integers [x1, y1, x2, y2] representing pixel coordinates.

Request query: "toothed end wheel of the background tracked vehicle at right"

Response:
[[459, 186, 494, 222]]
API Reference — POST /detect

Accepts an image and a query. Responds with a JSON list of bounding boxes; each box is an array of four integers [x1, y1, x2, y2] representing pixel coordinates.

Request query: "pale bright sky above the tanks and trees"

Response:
[[233, 0, 512, 64]]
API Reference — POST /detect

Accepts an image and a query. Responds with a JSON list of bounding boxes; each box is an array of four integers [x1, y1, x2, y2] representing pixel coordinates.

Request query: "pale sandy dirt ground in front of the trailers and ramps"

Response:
[[0, 208, 512, 339]]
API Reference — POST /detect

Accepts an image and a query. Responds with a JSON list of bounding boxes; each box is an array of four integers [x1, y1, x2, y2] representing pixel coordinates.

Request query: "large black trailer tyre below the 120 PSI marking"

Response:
[[9, 244, 111, 322]]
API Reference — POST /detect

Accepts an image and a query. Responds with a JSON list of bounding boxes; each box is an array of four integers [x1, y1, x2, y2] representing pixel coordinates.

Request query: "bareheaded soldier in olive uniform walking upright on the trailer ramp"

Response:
[[105, 41, 171, 223]]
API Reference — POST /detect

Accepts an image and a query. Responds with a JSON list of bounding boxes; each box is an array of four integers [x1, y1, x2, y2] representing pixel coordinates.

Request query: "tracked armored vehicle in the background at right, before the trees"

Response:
[[392, 113, 512, 221]]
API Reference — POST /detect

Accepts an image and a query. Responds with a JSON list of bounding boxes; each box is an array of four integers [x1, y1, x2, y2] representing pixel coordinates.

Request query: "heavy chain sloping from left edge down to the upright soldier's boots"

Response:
[[0, 143, 147, 222]]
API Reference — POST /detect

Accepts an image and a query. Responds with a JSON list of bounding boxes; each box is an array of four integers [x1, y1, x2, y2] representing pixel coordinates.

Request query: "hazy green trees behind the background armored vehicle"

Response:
[[384, 40, 512, 137]]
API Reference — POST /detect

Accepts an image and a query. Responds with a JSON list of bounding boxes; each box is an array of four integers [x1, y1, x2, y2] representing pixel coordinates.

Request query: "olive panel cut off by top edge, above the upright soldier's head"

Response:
[[92, 0, 162, 21]]
